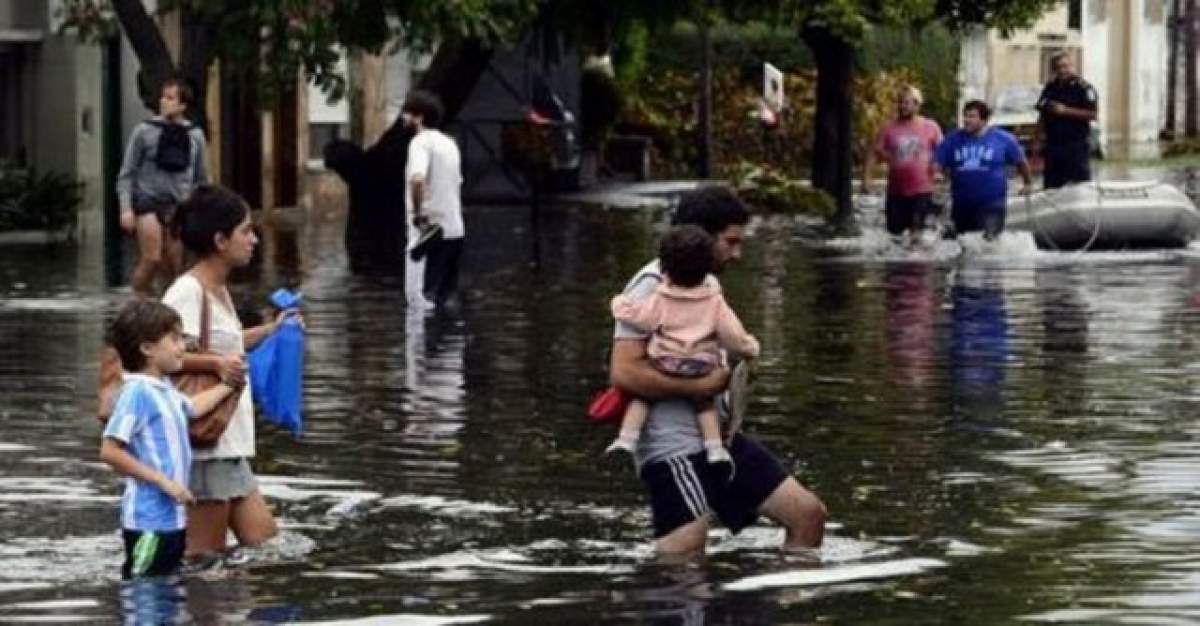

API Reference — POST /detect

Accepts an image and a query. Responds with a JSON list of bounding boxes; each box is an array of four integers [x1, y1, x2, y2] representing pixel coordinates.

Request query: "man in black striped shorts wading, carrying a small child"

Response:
[[611, 187, 826, 555]]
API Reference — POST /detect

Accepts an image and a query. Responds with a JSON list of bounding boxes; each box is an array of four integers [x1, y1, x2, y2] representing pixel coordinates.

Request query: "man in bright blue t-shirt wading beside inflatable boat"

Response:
[[937, 100, 1033, 240]]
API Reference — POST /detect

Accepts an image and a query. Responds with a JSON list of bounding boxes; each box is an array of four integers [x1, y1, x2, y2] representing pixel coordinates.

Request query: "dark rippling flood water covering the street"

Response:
[[0, 191, 1200, 626]]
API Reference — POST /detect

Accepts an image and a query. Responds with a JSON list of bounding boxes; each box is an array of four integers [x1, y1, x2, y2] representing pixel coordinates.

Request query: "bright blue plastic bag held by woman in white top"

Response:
[[247, 289, 305, 437]]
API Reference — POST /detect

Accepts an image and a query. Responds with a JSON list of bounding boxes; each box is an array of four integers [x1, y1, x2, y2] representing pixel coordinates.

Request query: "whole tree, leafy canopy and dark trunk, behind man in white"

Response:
[[62, 0, 539, 270]]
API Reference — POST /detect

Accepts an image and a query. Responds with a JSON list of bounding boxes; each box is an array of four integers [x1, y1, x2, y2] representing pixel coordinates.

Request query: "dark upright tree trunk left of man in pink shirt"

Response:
[[802, 28, 858, 233]]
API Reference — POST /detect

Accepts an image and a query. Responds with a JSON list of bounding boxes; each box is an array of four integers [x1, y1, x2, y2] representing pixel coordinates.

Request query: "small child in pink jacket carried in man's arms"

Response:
[[605, 225, 758, 463]]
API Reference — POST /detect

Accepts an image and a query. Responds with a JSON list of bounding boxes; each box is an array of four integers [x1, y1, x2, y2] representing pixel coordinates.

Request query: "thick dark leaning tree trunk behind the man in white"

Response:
[[324, 40, 492, 273]]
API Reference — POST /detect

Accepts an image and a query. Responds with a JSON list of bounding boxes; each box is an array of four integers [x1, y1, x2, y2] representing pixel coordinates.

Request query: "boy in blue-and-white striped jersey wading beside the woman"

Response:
[[100, 297, 234, 579]]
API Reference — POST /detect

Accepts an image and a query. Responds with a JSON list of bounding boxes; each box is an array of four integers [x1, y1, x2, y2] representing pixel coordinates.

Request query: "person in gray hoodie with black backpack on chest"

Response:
[[116, 78, 208, 295]]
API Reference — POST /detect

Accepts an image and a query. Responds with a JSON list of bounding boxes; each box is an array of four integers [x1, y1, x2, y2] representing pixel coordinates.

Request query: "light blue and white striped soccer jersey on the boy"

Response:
[[104, 374, 194, 530]]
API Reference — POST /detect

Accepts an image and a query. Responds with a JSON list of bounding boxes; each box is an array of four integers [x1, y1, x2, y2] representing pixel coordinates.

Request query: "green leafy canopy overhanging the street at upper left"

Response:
[[61, 0, 536, 127]]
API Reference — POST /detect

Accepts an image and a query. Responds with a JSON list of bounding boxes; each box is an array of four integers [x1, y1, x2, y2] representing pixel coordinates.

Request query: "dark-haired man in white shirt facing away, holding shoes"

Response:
[[400, 90, 464, 308]]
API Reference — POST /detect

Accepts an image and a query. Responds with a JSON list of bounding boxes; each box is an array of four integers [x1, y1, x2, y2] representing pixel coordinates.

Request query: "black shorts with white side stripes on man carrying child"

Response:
[[641, 434, 787, 538]]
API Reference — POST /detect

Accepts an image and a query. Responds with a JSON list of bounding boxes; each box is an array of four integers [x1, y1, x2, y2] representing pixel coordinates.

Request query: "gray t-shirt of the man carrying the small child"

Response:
[[613, 259, 704, 469]]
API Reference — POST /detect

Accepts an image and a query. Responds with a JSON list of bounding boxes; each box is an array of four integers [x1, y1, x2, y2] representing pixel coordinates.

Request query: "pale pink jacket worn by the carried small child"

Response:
[[612, 276, 758, 365]]
